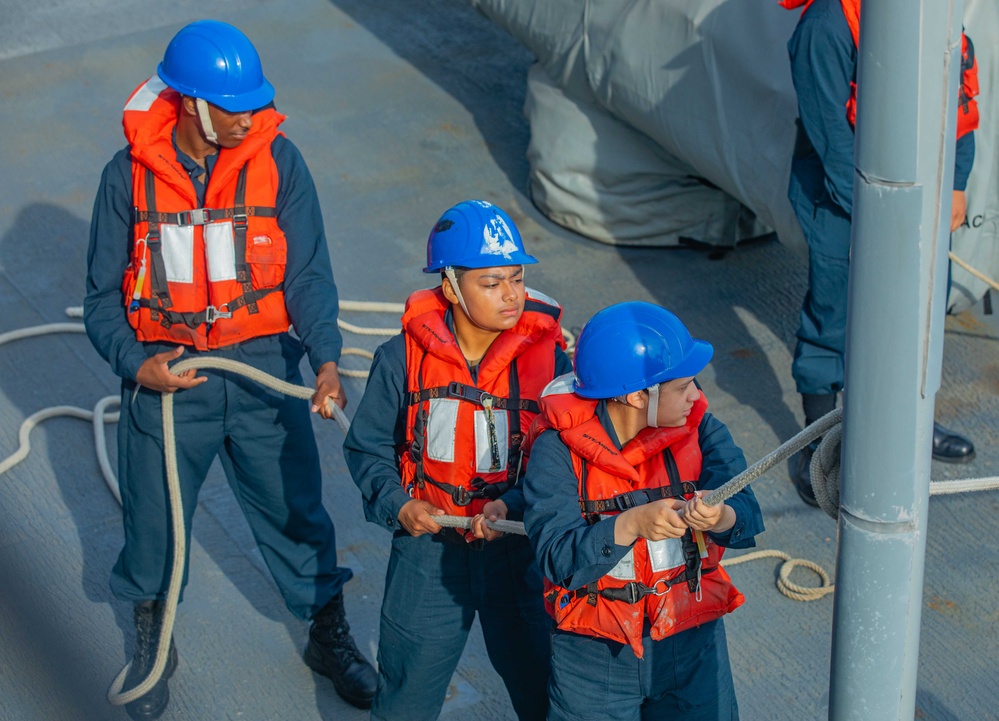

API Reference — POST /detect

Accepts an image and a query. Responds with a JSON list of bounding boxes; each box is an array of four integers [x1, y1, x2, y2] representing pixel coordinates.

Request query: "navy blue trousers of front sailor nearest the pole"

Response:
[[548, 619, 739, 721]]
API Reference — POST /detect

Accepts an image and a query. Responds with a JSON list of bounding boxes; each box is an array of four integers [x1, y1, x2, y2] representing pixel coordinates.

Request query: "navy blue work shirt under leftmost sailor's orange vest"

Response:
[[83, 124, 343, 380]]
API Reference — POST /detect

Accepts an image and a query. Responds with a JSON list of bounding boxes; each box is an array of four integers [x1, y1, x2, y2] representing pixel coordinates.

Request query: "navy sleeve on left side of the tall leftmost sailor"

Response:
[[83, 148, 155, 380]]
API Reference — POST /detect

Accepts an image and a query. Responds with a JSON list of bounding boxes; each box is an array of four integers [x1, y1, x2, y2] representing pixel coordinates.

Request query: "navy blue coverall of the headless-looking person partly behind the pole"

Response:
[[788, 0, 975, 396]]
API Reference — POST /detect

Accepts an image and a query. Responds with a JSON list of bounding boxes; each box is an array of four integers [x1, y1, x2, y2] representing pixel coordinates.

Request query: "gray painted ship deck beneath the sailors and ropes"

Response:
[[0, 0, 999, 721]]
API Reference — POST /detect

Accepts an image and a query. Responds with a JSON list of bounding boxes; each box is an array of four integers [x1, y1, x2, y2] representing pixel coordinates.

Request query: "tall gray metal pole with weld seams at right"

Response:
[[829, 0, 962, 721]]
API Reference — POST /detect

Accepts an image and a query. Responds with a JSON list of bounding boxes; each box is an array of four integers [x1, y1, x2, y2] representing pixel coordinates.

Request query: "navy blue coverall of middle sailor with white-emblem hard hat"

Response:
[[343, 324, 572, 721]]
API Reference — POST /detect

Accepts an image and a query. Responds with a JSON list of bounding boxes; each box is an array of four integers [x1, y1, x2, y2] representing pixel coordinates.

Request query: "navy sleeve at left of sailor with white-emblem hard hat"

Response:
[[343, 336, 420, 531]]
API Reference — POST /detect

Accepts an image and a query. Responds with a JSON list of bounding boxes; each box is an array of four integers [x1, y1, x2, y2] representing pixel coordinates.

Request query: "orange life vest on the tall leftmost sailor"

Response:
[[122, 76, 291, 350]]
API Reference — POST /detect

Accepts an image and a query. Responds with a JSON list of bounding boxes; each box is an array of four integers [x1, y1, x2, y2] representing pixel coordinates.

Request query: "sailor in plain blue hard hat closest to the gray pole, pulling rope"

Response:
[[524, 302, 763, 721]]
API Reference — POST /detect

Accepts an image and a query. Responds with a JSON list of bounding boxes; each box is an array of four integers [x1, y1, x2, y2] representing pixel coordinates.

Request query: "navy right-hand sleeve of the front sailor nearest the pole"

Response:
[[698, 413, 764, 548]]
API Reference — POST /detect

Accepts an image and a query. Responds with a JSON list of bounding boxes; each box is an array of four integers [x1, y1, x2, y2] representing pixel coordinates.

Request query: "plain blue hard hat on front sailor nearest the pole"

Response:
[[573, 301, 714, 398]]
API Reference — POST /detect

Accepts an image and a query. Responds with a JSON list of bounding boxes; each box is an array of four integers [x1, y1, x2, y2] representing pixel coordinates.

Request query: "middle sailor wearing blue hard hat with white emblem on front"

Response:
[[343, 200, 571, 721]]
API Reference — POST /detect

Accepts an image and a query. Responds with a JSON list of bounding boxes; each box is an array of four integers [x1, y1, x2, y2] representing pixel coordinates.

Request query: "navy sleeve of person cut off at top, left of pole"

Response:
[[788, 3, 857, 215]]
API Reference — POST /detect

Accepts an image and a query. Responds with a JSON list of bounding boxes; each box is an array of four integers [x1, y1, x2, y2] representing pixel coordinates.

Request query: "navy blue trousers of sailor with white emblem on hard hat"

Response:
[[371, 531, 551, 721]]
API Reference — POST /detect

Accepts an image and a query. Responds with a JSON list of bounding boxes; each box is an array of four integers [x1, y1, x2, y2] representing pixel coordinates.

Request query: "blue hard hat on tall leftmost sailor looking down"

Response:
[[156, 20, 274, 113]]
